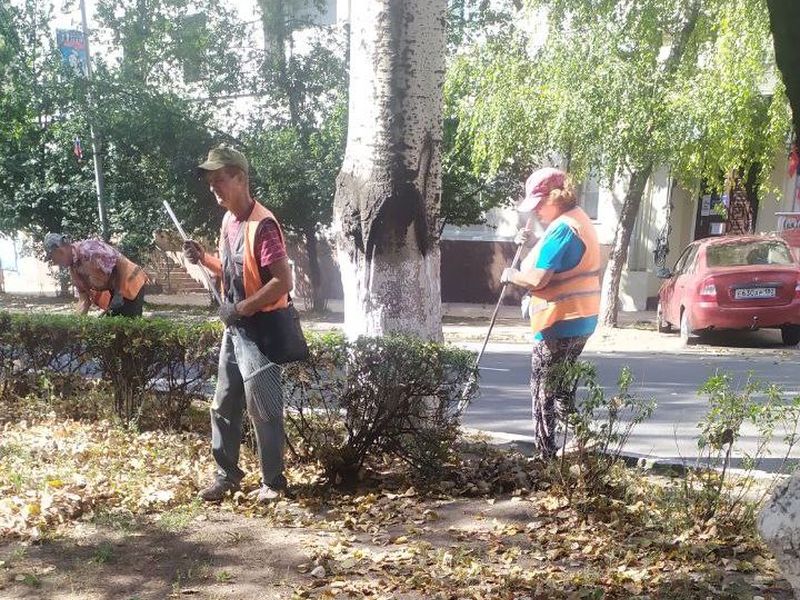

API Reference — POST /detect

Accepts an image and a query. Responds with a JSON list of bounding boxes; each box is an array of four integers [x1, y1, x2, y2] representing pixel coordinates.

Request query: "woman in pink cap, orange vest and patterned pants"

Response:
[[501, 167, 600, 458]]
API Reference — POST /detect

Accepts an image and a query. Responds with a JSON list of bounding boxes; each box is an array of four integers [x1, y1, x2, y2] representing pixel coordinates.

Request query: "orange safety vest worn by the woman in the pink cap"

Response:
[[525, 207, 600, 333]]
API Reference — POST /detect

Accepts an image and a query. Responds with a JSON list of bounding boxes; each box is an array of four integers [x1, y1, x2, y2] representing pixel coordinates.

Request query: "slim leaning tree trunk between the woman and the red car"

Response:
[[599, 165, 653, 327]]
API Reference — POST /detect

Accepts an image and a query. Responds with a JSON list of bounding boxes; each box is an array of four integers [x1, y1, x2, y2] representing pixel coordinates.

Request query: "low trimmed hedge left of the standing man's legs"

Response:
[[0, 313, 221, 428]]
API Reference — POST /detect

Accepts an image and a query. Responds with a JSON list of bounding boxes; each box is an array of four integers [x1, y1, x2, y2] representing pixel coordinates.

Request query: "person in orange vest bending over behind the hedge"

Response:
[[44, 233, 147, 317]]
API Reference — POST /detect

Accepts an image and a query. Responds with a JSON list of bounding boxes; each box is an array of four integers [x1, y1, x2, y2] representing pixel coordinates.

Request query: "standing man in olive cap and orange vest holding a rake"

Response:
[[184, 146, 293, 503]]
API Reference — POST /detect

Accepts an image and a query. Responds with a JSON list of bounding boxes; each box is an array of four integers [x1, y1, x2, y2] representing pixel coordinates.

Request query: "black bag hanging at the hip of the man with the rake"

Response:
[[248, 298, 308, 365]]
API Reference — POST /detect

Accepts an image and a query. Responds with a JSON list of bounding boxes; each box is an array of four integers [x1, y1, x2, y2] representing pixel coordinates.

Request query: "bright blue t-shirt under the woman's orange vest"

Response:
[[534, 223, 597, 340]]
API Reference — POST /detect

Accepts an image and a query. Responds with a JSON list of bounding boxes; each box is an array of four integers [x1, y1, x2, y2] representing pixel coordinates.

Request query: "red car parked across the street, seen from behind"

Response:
[[656, 236, 800, 346]]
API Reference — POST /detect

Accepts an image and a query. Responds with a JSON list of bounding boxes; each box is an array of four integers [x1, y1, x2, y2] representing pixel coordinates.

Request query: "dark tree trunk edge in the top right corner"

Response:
[[767, 0, 800, 135]]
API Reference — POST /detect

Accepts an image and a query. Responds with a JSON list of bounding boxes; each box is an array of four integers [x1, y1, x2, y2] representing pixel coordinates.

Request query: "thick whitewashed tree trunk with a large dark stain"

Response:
[[333, 0, 447, 340]]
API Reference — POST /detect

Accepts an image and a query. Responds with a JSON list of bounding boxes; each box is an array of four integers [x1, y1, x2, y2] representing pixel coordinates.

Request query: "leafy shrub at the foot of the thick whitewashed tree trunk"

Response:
[[285, 334, 474, 483]]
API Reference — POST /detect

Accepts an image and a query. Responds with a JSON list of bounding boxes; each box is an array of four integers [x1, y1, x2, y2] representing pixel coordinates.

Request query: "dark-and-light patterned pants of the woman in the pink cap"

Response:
[[531, 336, 589, 457]]
